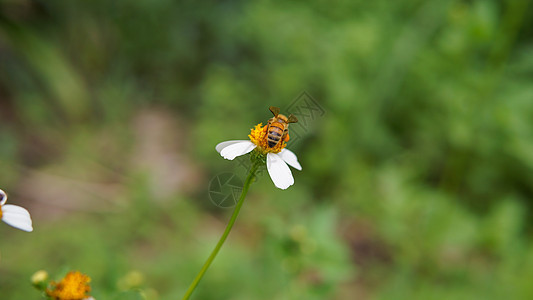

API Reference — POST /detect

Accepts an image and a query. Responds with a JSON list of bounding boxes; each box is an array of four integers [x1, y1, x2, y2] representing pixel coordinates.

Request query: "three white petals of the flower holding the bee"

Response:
[[216, 140, 302, 190]]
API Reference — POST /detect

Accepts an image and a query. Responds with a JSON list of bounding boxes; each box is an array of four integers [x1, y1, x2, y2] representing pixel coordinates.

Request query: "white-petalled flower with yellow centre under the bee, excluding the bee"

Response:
[[215, 120, 302, 190]]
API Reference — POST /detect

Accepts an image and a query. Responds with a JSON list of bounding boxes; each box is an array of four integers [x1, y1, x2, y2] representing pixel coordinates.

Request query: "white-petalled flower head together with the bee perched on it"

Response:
[[216, 106, 302, 190]]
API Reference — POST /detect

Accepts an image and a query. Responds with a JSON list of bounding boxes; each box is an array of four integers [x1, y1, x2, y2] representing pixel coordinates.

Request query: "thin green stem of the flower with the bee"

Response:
[[182, 163, 259, 300]]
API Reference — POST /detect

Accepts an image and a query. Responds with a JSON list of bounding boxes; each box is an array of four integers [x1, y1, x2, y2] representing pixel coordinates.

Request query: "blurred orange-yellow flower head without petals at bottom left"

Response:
[[46, 271, 91, 300]]
